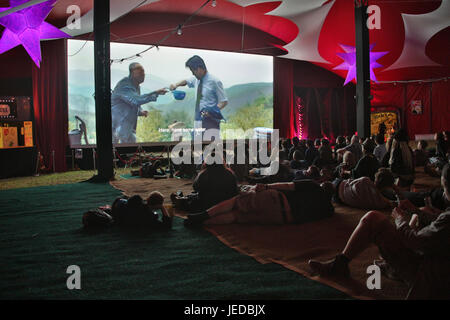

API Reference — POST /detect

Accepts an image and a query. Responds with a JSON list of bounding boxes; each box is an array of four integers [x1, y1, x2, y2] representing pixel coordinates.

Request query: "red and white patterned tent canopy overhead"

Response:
[[0, 0, 450, 82]]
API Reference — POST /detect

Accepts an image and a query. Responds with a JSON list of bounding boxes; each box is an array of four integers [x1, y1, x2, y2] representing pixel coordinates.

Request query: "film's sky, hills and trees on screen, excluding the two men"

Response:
[[67, 40, 273, 144]]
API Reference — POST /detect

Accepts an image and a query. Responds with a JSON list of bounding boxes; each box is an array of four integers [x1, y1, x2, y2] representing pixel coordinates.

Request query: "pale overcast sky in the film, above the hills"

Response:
[[67, 40, 273, 88]]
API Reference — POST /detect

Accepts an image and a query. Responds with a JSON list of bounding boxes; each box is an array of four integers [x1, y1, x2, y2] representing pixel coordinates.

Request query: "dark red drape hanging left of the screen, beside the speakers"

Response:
[[32, 39, 68, 172]]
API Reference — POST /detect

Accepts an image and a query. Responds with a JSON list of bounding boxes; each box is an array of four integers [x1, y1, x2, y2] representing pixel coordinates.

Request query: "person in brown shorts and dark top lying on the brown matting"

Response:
[[185, 180, 334, 226]]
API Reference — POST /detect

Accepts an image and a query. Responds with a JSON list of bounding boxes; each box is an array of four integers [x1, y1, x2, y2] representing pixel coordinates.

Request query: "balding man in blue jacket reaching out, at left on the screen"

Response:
[[111, 62, 167, 143]]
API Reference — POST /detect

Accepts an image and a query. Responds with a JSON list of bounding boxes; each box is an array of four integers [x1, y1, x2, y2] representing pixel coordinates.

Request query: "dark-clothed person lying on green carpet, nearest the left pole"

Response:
[[111, 191, 172, 230]]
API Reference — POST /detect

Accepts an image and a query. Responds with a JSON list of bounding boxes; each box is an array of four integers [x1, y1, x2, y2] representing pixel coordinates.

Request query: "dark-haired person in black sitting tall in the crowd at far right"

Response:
[[388, 129, 415, 187]]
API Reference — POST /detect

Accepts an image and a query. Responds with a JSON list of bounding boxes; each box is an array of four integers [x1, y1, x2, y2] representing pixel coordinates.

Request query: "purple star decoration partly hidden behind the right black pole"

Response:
[[334, 44, 388, 86]]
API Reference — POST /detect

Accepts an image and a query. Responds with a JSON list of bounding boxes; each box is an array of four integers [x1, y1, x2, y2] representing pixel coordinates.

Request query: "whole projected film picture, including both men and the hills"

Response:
[[68, 40, 273, 144]]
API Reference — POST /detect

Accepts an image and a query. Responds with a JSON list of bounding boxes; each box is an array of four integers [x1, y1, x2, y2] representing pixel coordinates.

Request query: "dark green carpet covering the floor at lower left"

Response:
[[0, 183, 349, 300]]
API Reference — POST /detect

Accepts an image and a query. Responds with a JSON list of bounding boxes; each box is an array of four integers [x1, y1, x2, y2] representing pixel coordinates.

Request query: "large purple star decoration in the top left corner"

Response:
[[0, 0, 70, 68]]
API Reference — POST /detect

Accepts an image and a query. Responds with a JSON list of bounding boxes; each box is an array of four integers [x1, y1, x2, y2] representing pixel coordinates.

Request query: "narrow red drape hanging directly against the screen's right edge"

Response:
[[273, 58, 295, 138]]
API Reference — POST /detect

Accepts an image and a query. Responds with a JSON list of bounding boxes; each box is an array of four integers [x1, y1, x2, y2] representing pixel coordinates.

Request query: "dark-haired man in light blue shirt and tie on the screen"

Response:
[[170, 56, 228, 139]]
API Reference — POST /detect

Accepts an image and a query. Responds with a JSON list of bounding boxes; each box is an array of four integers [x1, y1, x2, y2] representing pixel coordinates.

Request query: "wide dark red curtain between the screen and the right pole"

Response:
[[274, 58, 356, 140]]
